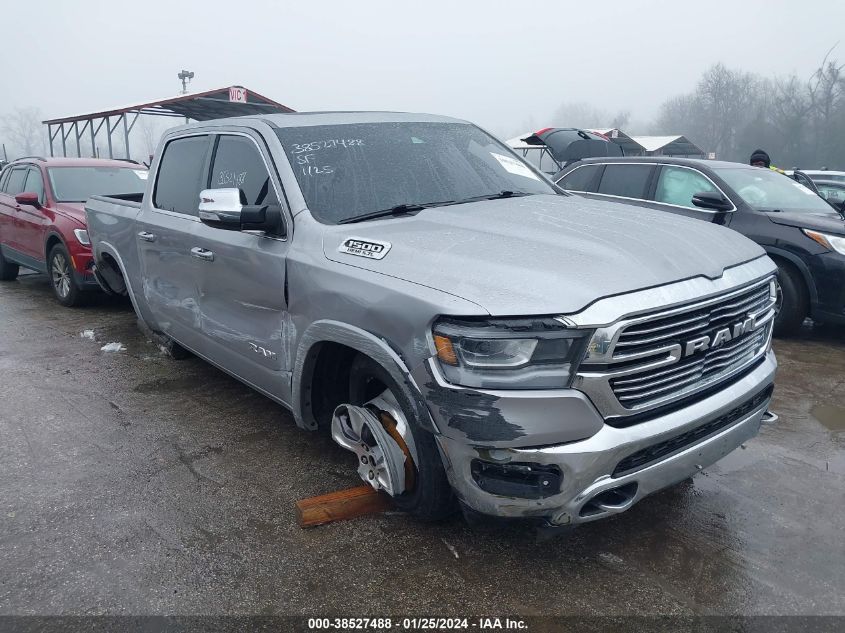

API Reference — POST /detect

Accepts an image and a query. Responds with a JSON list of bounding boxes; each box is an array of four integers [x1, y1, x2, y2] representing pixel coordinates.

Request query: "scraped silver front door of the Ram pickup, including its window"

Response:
[[194, 133, 289, 400]]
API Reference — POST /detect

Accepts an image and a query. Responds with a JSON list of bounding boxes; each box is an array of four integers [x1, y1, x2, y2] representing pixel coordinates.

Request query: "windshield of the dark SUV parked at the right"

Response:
[[714, 167, 833, 213]]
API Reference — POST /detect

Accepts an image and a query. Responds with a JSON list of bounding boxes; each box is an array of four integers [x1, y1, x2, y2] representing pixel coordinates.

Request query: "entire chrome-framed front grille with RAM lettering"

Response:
[[574, 277, 775, 427]]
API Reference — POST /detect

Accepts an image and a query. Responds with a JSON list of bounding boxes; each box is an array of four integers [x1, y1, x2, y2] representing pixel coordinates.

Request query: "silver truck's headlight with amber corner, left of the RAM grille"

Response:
[[433, 318, 592, 389]]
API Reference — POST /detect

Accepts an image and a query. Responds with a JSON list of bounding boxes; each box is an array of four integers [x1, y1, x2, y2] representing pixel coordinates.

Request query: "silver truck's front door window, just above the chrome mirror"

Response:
[[209, 136, 279, 206]]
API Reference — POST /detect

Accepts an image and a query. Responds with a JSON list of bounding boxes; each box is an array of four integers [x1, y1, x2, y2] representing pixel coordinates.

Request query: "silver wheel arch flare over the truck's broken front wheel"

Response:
[[291, 320, 435, 431]]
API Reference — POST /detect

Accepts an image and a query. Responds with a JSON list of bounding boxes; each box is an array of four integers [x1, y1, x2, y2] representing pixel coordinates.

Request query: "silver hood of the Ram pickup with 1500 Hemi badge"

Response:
[[323, 195, 764, 316]]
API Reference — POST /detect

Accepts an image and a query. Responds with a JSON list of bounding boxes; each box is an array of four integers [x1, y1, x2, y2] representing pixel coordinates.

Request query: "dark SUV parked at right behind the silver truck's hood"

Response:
[[554, 157, 845, 335]]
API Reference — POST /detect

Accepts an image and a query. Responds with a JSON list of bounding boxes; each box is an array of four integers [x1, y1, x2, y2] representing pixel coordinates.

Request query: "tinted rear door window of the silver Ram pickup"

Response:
[[153, 136, 208, 216]]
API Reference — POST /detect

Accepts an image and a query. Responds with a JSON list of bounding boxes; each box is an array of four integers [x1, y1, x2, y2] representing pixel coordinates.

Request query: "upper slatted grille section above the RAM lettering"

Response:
[[613, 282, 771, 359]]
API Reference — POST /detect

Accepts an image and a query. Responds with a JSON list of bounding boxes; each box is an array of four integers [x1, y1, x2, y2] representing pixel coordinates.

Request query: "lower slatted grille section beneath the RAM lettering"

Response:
[[610, 327, 768, 409]]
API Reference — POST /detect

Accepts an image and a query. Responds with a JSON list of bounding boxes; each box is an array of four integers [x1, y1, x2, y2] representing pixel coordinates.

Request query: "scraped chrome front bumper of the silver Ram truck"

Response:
[[435, 351, 777, 525]]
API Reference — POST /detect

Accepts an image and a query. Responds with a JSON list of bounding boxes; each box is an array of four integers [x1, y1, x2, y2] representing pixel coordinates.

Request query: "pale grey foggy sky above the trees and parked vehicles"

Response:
[[0, 0, 845, 134]]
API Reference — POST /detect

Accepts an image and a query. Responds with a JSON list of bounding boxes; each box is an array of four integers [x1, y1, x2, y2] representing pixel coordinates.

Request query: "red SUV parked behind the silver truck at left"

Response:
[[0, 158, 147, 306]]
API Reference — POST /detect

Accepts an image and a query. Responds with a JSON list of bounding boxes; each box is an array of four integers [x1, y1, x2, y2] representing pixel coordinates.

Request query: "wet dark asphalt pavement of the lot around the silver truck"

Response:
[[0, 275, 845, 615]]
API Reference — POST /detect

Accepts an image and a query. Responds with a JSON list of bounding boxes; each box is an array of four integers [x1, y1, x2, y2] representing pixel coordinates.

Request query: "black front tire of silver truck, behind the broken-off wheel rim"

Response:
[[349, 354, 458, 521]]
